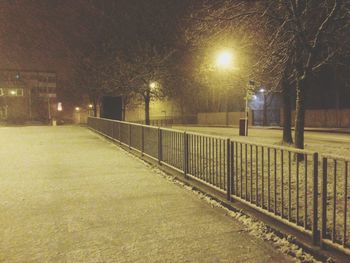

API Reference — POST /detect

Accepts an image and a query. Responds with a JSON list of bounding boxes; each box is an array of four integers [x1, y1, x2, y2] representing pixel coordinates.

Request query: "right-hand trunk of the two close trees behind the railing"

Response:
[[294, 78, 306, 149]]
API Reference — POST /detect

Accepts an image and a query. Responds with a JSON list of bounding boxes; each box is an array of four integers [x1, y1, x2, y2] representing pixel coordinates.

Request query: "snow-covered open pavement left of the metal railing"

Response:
[[0, 126, 290, 262]]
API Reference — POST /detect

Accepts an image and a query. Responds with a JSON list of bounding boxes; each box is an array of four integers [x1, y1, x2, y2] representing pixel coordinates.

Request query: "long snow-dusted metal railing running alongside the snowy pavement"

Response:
[[88, 117, 350, 255]]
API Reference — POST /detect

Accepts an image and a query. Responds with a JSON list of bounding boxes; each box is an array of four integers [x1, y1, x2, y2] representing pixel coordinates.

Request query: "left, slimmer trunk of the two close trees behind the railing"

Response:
[[282, 80, 293, 144]]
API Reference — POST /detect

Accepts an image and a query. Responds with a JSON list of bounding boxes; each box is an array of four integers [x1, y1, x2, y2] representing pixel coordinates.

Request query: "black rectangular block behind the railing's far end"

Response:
[[101, 96, 123, 121]]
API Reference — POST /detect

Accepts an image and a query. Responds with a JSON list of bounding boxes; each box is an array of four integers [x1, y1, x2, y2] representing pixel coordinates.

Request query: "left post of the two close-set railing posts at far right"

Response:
[[312, 153, 319, 245]]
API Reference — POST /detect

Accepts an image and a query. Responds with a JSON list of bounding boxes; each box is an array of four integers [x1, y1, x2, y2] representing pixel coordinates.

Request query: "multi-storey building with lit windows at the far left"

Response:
[[0, 69, 57, 122]]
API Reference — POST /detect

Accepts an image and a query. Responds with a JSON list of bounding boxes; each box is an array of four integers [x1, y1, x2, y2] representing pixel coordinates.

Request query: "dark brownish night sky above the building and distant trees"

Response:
[[0, 0, 193, 77]]
